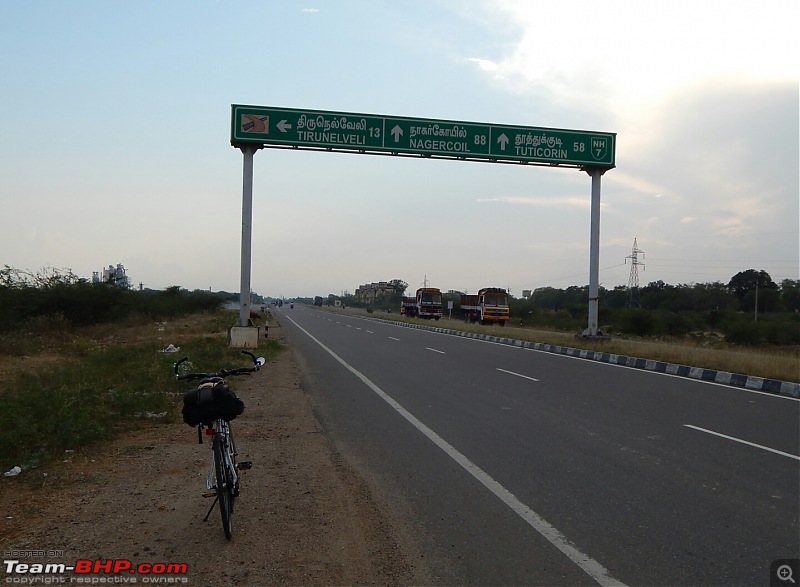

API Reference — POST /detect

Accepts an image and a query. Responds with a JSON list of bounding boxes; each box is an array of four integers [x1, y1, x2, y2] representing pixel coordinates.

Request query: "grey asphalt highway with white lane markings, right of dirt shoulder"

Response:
[[278, 306, 800, 585]]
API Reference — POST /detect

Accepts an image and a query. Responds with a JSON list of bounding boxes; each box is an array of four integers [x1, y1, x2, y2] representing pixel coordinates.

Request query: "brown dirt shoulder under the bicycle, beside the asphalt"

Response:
[[0, 325, 429, 586]]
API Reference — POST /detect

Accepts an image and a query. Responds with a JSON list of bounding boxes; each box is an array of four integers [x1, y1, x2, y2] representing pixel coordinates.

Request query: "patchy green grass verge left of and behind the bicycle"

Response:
[[0, 311, 283, 470]]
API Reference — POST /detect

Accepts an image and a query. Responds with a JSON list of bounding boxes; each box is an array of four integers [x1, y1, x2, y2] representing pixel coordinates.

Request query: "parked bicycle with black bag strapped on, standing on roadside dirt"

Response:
[[173, 351, 266, 540]]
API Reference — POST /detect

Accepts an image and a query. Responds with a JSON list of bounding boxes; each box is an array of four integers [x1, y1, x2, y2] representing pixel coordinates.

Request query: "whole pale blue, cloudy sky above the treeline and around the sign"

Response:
[[0, 0, 800, 297]]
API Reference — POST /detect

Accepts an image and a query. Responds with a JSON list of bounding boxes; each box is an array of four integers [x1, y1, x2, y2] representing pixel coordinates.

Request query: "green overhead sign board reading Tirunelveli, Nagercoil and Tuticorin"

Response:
[[231, 104, 616, 167]]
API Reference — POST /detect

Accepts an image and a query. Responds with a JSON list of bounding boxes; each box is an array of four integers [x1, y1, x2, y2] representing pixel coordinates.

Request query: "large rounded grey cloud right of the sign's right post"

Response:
[[588, 78, 800, 279]]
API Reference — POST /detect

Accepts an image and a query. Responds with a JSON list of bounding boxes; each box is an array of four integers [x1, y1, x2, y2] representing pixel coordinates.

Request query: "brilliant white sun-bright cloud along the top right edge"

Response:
[[468, 0, 798, 118]]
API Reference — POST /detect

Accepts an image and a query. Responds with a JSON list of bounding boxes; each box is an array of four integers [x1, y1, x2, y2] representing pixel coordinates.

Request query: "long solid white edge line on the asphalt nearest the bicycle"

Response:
[[286, 316, 625, 587]]
